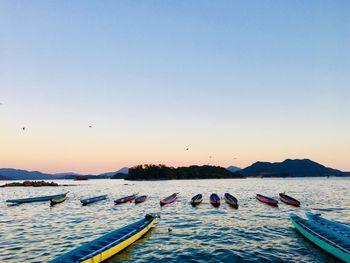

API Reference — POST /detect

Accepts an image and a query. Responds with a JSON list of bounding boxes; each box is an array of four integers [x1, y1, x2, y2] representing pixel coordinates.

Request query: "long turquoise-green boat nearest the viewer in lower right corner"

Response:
[[290, 213, 350, 262]]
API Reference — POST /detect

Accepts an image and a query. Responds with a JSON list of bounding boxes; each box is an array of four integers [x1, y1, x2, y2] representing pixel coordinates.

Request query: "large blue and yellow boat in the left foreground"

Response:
[[51, 214, 157, 263]]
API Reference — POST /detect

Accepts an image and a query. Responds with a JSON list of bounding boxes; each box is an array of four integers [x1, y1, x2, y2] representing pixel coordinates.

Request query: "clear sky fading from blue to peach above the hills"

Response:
[[0, 0, 350, 173]]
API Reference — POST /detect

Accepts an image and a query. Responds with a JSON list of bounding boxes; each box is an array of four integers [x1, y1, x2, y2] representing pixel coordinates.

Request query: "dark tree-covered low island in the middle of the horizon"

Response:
[[125, 164, 245, 181]]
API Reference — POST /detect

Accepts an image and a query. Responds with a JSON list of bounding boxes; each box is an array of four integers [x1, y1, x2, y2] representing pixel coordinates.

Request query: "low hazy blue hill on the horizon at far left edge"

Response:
[[0, 168, 57, 180]]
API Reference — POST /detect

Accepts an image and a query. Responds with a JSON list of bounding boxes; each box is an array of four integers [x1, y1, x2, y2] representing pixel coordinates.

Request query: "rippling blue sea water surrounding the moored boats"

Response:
[[0, 178, 350, 262]]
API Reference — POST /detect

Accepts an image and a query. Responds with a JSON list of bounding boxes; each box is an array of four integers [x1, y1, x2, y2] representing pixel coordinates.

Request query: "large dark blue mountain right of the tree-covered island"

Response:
[[240, 159, 348, 177]]
